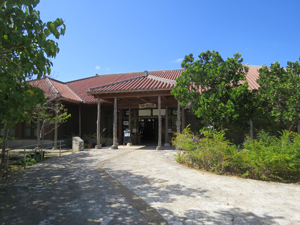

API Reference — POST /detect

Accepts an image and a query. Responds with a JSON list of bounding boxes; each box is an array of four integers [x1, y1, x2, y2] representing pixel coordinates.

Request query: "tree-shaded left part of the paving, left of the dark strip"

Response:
[[0, 152, 147, 225]]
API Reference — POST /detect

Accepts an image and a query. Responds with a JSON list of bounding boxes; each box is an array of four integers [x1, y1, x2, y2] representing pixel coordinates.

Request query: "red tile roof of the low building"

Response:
[[30, 65, 260, 103]]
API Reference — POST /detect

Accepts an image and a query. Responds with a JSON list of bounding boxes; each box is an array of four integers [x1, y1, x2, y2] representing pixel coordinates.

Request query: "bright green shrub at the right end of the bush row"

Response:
[[238, 130, 300, 182]]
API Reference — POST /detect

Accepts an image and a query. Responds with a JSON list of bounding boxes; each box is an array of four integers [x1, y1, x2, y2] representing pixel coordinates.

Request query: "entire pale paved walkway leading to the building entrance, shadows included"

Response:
[[0, 145, 300, 225]]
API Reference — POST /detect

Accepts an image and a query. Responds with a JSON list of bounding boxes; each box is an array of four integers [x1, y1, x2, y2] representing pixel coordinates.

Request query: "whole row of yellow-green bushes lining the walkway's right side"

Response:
[[172, 127, 300, 182]]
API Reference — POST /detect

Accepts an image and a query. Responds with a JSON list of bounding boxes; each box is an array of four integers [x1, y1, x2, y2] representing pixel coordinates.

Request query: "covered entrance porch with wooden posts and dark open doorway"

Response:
[[89, 90, 186, 150]]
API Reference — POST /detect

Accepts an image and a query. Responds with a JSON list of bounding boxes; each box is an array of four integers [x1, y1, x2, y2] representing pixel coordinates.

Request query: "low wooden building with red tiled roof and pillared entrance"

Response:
[[13, 66, 260, 149]]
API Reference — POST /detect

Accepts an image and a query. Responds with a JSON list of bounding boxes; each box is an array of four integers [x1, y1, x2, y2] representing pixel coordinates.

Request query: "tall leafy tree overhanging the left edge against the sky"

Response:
[[0, 0, 65, 178]]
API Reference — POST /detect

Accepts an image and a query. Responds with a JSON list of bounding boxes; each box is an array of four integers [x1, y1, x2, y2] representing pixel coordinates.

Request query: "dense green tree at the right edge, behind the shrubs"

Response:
[[257, 61, 300, 130]]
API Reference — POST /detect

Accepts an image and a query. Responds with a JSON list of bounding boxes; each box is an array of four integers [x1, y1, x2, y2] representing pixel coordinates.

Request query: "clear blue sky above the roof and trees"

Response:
[[37, 0, 300, 81]]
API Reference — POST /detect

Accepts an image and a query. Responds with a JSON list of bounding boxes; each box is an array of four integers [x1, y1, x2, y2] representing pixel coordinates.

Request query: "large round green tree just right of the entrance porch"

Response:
[[172, 51, 253, 130]]
